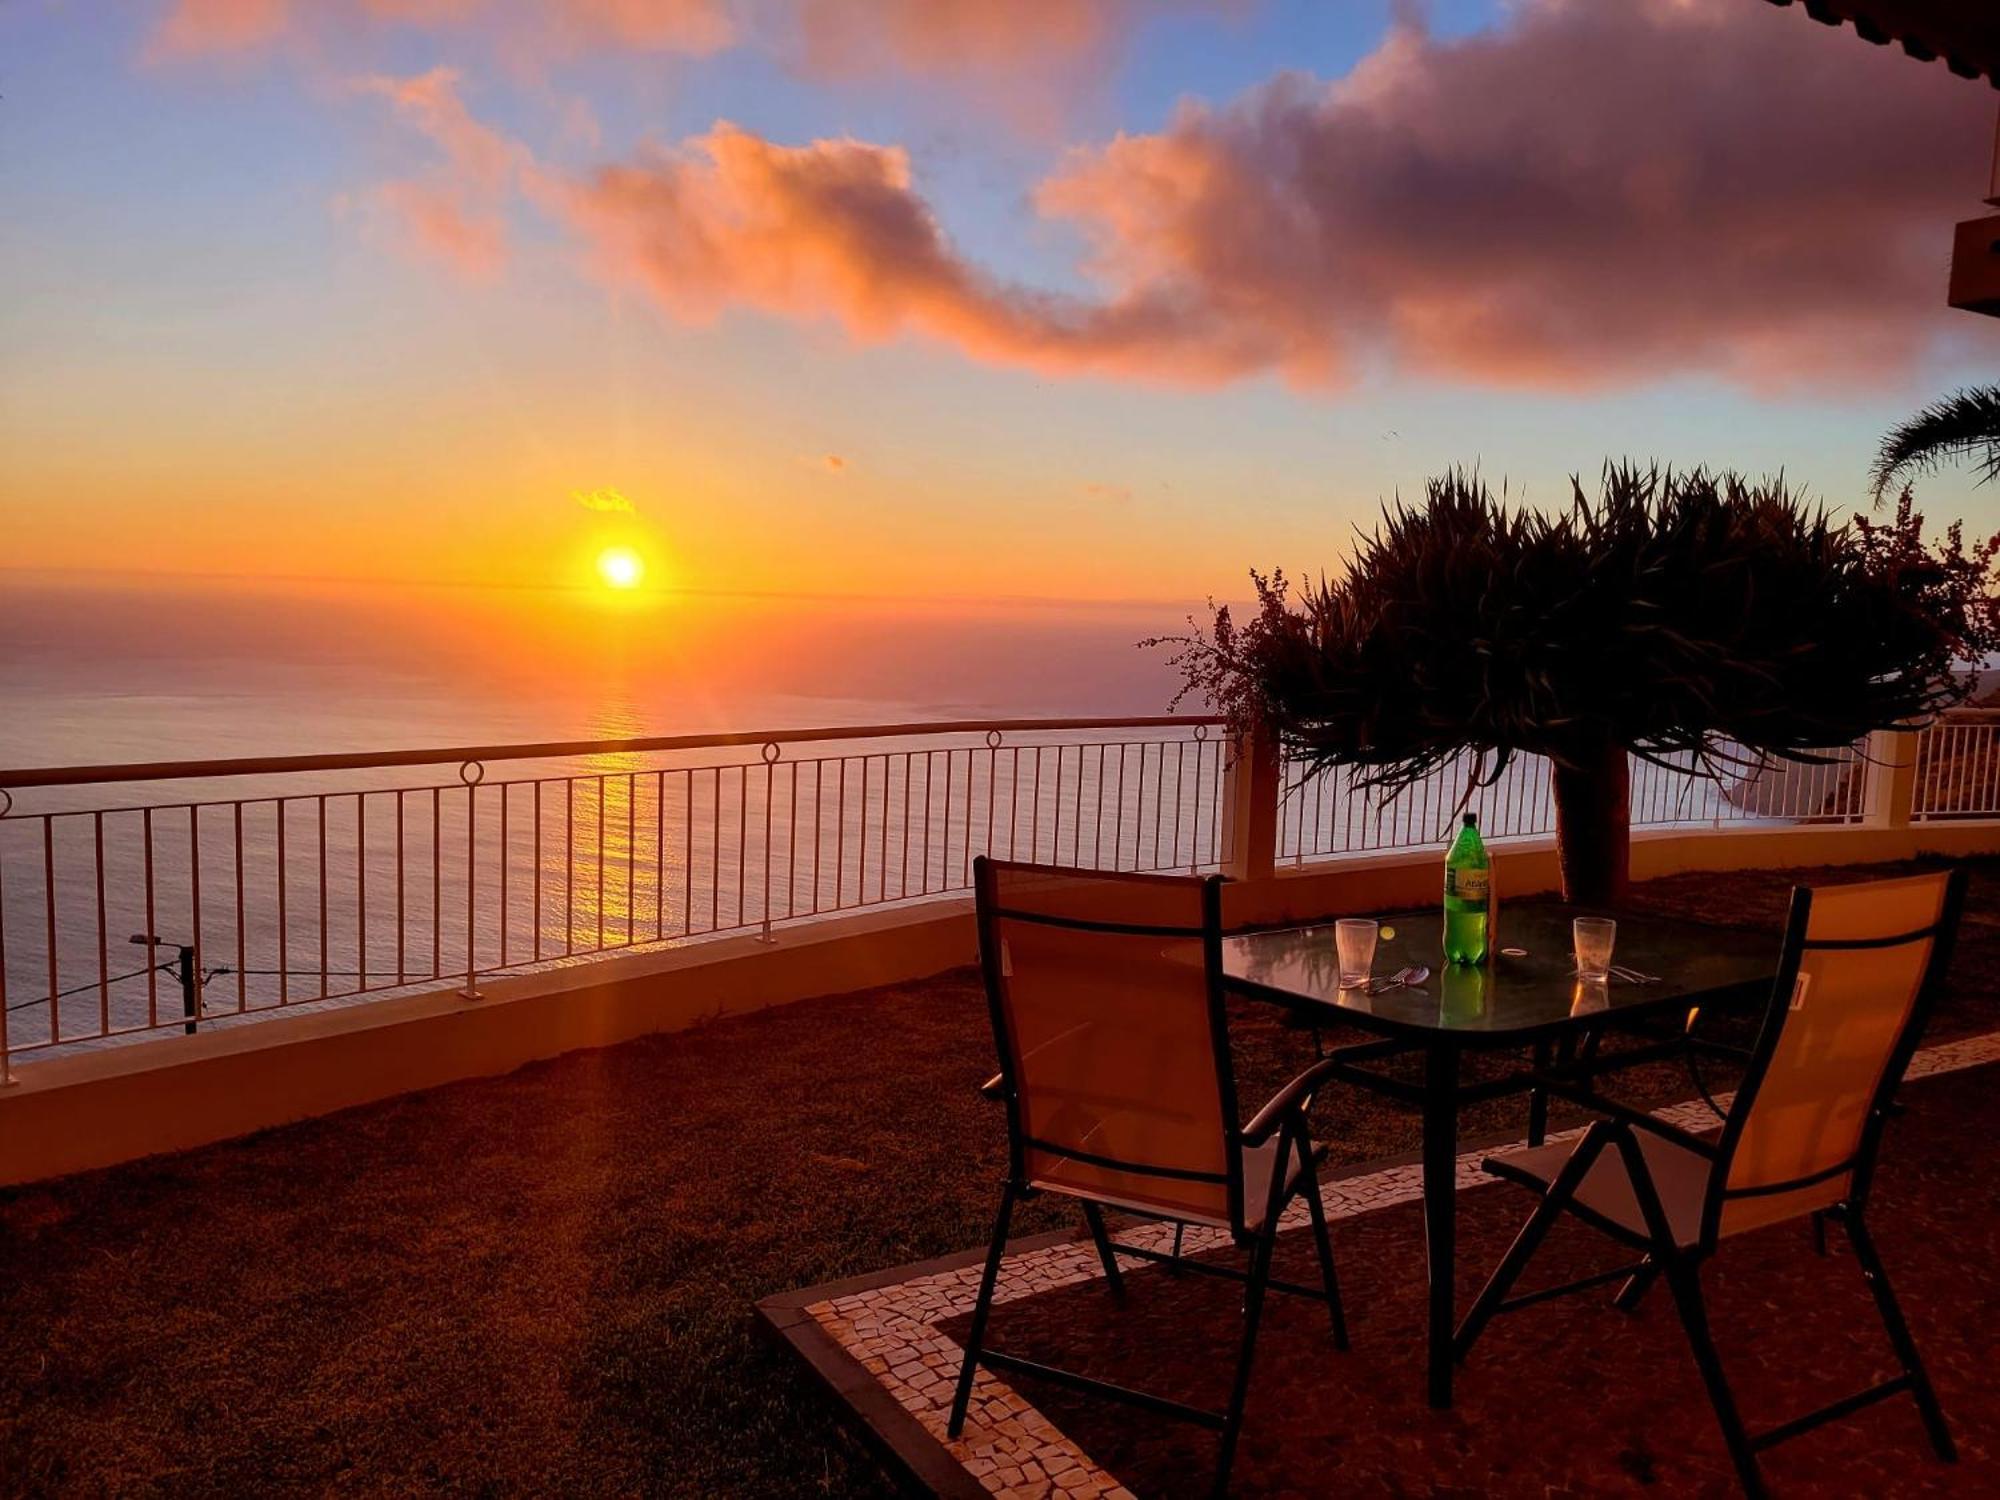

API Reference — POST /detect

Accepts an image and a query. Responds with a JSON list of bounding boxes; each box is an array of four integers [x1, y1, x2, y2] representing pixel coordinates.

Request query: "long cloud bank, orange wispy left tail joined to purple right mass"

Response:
[[364, 0, 1992, 388]]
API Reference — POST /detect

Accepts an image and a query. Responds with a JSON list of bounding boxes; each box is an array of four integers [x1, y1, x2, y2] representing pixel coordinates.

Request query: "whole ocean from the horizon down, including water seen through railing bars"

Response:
[[0, 578, 1222, 1060]]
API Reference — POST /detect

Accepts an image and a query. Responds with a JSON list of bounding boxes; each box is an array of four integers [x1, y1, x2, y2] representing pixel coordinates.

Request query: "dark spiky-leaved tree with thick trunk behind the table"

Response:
[[1170, 464, 2000, 902]]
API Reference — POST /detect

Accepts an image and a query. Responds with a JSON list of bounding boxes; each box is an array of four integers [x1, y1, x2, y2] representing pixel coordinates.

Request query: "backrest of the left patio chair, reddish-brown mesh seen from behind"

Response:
[[974, 858, 1244, 1228]]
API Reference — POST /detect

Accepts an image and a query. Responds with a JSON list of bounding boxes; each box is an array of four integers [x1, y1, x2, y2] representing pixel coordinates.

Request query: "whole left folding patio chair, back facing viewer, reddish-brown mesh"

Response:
[[948, 858, 1348, 1494]]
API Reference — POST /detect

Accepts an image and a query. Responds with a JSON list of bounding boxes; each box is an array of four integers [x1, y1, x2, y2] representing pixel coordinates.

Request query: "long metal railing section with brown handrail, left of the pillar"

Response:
[[0, 718, 1226, 1068]]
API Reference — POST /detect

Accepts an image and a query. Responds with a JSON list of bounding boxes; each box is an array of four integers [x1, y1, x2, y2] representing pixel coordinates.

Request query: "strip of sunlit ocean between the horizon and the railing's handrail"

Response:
[[0, 574, 1192, 768]]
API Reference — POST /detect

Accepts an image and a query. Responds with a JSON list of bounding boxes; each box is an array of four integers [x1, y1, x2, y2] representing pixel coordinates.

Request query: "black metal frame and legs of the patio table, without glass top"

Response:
[[1222, 924, 1776, 1410]]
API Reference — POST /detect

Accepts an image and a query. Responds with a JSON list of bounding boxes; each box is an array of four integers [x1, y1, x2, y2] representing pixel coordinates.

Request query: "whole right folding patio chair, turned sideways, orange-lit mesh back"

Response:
[[1454, 870, 1966, 1496]]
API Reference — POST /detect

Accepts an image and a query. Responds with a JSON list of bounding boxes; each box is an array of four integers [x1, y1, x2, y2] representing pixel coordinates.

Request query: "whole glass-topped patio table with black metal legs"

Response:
[[1222, 900, 1778, 1408]]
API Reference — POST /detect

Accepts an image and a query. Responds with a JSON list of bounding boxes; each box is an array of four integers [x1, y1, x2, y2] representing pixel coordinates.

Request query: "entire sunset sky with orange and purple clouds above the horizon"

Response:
[[0, 0, 2000, 600]]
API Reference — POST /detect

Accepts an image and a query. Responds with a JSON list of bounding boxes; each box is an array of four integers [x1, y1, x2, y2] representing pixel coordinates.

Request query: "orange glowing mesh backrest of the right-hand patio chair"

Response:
[[1702, 870, 1966, 1242]]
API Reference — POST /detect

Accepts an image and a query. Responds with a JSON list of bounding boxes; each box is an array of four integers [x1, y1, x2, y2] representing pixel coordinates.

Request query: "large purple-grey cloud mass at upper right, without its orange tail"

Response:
[[1038, 0, 1992, 386]]
